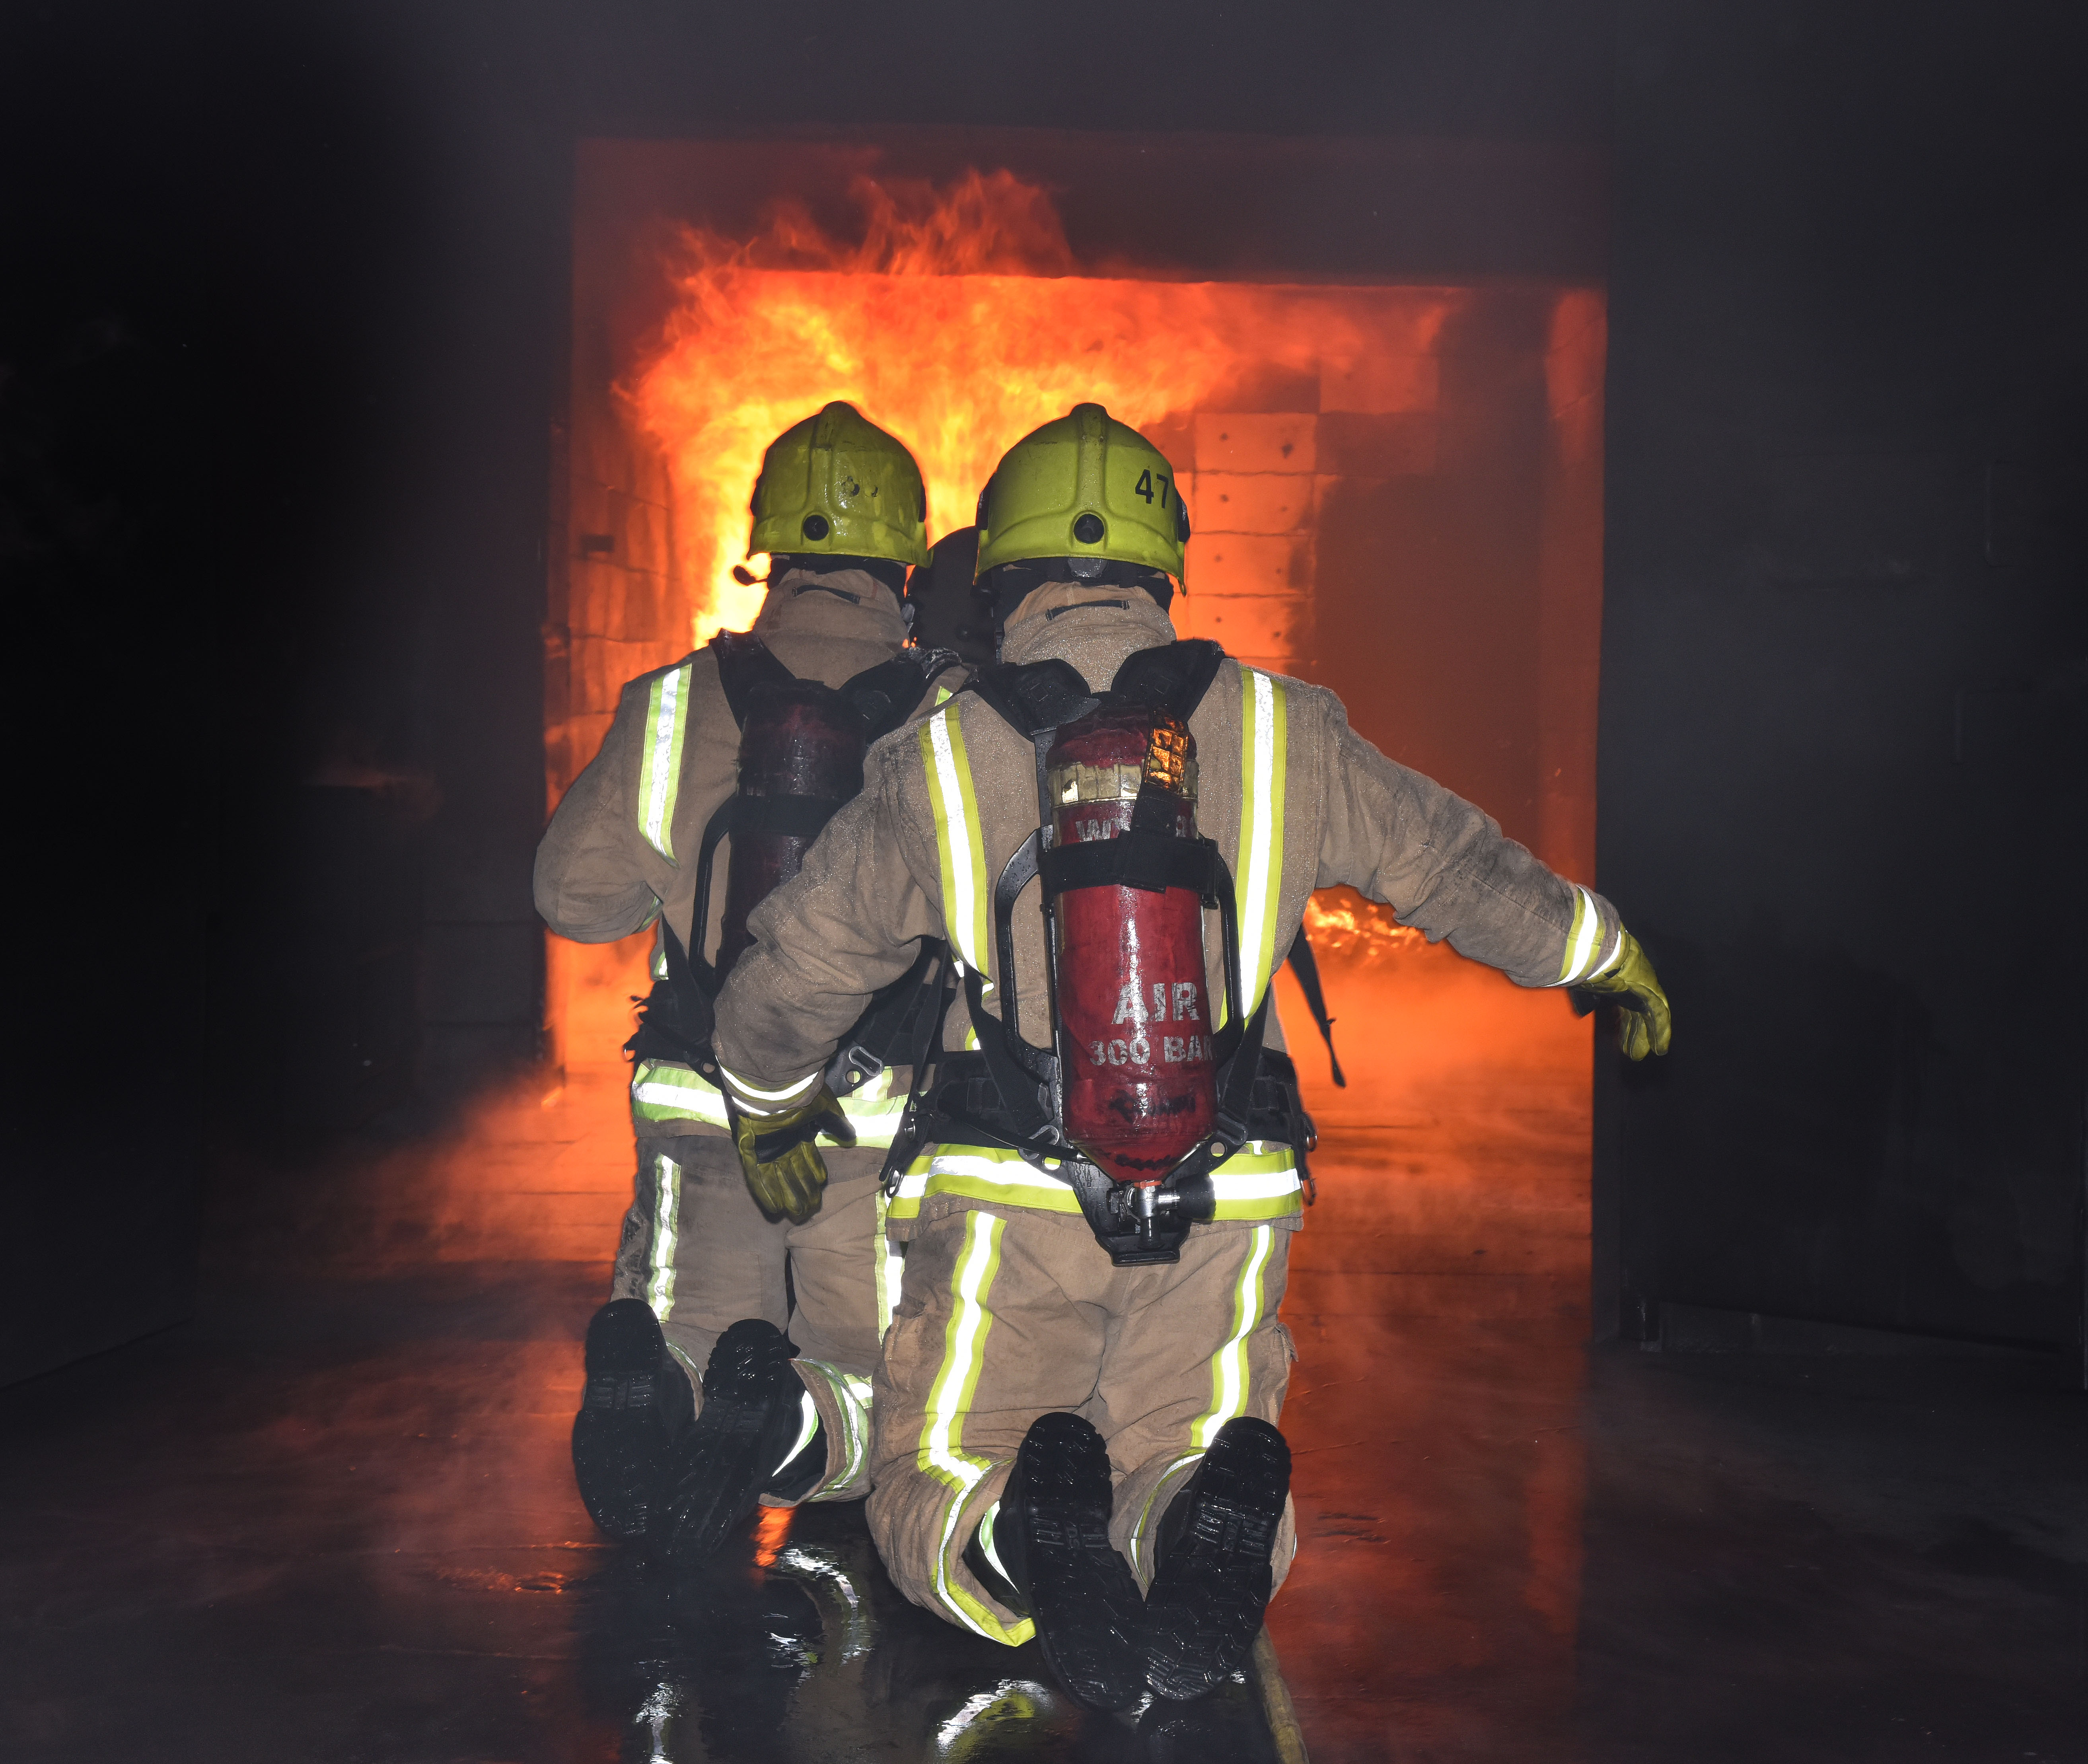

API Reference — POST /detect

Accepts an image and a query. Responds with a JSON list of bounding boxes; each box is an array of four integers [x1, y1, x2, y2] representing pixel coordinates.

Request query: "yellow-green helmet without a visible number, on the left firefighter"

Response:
[[747, 401, 927, 564]]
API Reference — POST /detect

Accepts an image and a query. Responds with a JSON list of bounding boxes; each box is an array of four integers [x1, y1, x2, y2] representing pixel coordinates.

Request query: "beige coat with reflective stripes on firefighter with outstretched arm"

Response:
[[716, 582, 1620, 1152]]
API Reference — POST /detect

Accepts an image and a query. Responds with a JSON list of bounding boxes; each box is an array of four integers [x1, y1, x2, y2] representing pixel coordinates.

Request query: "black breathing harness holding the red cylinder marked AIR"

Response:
[[887, 639, 1311, 1267]]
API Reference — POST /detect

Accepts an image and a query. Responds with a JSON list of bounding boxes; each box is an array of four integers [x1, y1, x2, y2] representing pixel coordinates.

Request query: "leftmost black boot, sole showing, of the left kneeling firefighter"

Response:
[[572, 1299, 695, 1543]]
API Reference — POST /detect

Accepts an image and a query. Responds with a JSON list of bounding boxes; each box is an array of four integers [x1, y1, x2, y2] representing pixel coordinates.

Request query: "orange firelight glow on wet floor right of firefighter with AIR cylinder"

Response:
[[1269, 942, 1591, 1760]]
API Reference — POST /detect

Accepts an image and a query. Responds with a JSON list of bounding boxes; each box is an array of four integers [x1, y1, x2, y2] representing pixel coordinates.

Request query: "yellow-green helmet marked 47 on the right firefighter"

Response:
[[979, 405, 1188, 582]]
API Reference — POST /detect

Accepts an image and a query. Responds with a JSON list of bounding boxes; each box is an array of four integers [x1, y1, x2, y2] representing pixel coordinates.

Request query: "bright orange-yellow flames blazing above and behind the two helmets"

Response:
[[618, 171, 1364, 643]]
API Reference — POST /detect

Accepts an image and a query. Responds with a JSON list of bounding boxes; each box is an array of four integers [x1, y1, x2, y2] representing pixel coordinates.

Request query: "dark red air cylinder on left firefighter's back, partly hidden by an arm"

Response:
[[718, 681, 866, 979]]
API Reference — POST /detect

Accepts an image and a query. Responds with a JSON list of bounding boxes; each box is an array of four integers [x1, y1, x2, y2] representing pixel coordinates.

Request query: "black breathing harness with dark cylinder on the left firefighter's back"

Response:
[[624, 631, 958, 1100]]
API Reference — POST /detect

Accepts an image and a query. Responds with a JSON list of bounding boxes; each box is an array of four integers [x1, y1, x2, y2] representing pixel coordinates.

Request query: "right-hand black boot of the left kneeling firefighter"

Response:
[[666, 1317, 825, 1568]]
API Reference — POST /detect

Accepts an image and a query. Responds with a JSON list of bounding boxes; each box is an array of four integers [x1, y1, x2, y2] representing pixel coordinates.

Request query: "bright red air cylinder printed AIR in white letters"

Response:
[[1044, 708, 1217, 1184]]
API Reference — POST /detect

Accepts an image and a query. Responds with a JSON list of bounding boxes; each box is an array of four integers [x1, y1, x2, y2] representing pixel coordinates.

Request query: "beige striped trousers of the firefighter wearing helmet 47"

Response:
[[869, 1196, 1297, 1647]]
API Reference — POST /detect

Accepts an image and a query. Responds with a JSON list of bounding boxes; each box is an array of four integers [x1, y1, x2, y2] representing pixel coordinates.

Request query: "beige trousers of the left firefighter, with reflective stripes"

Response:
[[610, 1133, 896, 1501]]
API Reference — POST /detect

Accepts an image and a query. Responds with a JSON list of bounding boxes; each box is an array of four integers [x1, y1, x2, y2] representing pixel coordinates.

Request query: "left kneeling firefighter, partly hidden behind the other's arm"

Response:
[[537, 403, 963, 1563]]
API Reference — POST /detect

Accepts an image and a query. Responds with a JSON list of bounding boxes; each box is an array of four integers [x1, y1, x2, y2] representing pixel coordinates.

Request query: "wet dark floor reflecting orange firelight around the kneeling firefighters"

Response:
[[0, 952, 2088, 1764]]
